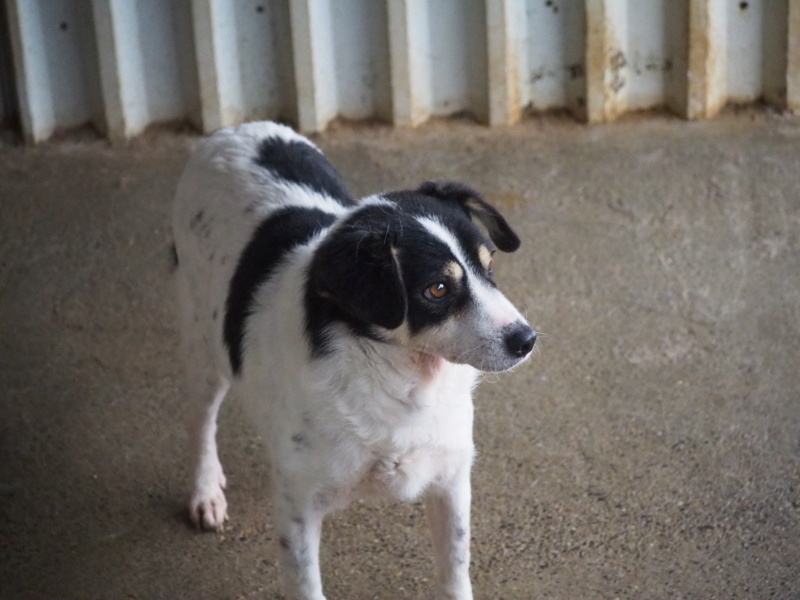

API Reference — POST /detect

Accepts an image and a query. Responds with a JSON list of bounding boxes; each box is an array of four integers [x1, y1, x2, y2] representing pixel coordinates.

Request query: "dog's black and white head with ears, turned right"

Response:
[[309, 182, 536, 371]]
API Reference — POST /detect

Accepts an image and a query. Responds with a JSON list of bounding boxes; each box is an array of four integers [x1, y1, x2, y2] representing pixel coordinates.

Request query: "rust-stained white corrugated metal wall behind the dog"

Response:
[[0, 0, 800, 142]]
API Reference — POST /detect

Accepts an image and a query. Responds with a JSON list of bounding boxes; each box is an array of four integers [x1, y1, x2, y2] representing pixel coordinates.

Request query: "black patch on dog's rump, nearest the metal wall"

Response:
[[255, 136, 355, 206]]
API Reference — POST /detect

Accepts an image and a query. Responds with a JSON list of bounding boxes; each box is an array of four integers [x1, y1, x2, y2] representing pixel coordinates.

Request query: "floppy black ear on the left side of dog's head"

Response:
[[309, 224, 406, 329]]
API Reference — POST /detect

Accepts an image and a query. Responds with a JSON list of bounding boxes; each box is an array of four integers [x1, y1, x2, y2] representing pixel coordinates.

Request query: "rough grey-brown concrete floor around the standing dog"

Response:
[[0, 113, 800, 600]]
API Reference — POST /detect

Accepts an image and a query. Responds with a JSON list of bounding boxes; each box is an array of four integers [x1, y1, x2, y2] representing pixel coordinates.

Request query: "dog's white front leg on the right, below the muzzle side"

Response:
[[425, 465, 472, 600]]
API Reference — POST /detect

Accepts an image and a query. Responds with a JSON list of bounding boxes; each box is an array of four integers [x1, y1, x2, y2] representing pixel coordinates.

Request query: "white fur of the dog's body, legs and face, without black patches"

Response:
[[173, 123, 532, 600]]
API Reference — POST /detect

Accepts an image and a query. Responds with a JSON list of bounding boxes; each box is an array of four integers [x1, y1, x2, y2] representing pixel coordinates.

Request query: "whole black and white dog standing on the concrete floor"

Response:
[[173, 123, 536, 600]]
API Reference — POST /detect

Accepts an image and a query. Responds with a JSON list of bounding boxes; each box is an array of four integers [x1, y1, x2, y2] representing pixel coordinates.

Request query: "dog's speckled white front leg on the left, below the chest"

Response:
[[273, 488, 325, 600]]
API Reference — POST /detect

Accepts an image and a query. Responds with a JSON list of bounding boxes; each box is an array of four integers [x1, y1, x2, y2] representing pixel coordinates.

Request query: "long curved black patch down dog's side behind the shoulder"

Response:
[[223, 207, 336, 375]]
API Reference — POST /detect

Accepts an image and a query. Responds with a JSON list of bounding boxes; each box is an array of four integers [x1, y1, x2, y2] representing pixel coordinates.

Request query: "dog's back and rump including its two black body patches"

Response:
[[173, 122, 355, 375]]
